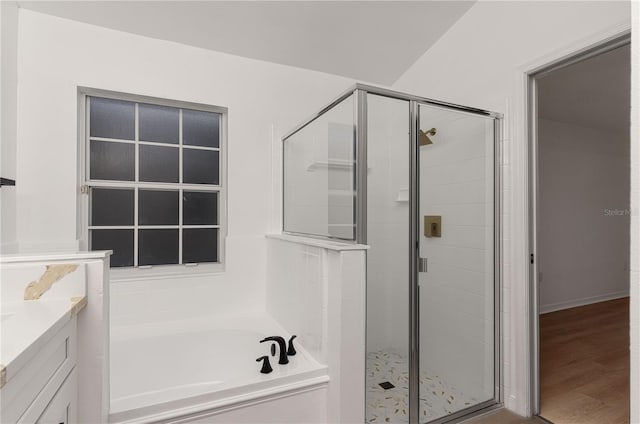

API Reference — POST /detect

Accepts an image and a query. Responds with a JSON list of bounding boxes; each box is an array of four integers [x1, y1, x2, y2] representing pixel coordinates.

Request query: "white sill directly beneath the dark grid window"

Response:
[[110, 263, 225, 283]]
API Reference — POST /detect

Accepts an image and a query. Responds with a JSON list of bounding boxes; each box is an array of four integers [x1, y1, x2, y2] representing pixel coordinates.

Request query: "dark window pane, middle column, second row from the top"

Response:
[[140, 145, 180, 183]]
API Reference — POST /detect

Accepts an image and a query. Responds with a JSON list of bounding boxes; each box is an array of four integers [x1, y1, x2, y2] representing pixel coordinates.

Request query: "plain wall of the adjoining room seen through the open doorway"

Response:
[[538, 119, 630, 313]]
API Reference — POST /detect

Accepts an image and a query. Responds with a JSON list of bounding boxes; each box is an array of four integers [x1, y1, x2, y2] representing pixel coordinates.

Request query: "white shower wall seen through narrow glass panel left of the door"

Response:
[[367, 95, 409, 358]]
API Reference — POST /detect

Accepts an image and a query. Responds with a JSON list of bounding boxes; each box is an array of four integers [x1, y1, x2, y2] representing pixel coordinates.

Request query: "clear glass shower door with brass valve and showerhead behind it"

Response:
[[415, 104, 498, 423]]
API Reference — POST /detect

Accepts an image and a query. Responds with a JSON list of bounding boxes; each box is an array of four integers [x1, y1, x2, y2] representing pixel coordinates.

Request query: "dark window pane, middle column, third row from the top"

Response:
[[138, 190, 179, 225]]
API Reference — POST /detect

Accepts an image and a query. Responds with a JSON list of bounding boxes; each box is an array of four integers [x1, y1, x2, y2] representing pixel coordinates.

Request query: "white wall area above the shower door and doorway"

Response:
[[393, 0, 630, 112]]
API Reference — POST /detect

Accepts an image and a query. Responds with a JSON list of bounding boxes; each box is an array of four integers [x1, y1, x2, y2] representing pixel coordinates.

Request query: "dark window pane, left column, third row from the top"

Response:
[[91, 188, 134, 225]]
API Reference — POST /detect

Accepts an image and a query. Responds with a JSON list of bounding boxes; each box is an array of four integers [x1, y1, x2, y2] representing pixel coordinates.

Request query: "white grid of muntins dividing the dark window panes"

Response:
[[85, 95, 224, 269]]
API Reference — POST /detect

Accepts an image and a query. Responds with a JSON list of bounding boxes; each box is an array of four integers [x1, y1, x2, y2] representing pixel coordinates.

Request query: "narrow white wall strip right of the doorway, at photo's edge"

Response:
[[630, 2, 640, 424]]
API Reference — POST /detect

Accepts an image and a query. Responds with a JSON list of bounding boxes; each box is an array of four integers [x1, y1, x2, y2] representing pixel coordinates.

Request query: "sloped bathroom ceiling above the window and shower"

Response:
[[18, 0, 475, 85]]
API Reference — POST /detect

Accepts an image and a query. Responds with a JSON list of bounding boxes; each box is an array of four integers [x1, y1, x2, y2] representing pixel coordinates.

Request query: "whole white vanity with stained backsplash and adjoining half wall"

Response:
[[0, 251, 111, 424]]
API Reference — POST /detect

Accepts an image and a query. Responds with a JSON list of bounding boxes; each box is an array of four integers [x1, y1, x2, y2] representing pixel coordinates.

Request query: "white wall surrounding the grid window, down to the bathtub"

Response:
[[15, 9, 352, 326]]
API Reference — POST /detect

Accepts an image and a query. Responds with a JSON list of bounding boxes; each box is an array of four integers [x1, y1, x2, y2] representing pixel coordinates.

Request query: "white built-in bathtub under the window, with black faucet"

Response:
[[110, 315, 328, 422]]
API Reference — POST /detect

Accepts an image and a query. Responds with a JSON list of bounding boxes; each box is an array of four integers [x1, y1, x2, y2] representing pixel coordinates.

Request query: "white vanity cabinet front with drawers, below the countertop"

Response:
[[0, 316, 78, 424]]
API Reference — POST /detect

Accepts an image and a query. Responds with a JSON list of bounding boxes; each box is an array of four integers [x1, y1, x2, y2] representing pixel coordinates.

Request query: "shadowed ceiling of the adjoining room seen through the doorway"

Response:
[[538, 44, 631, 133]]
